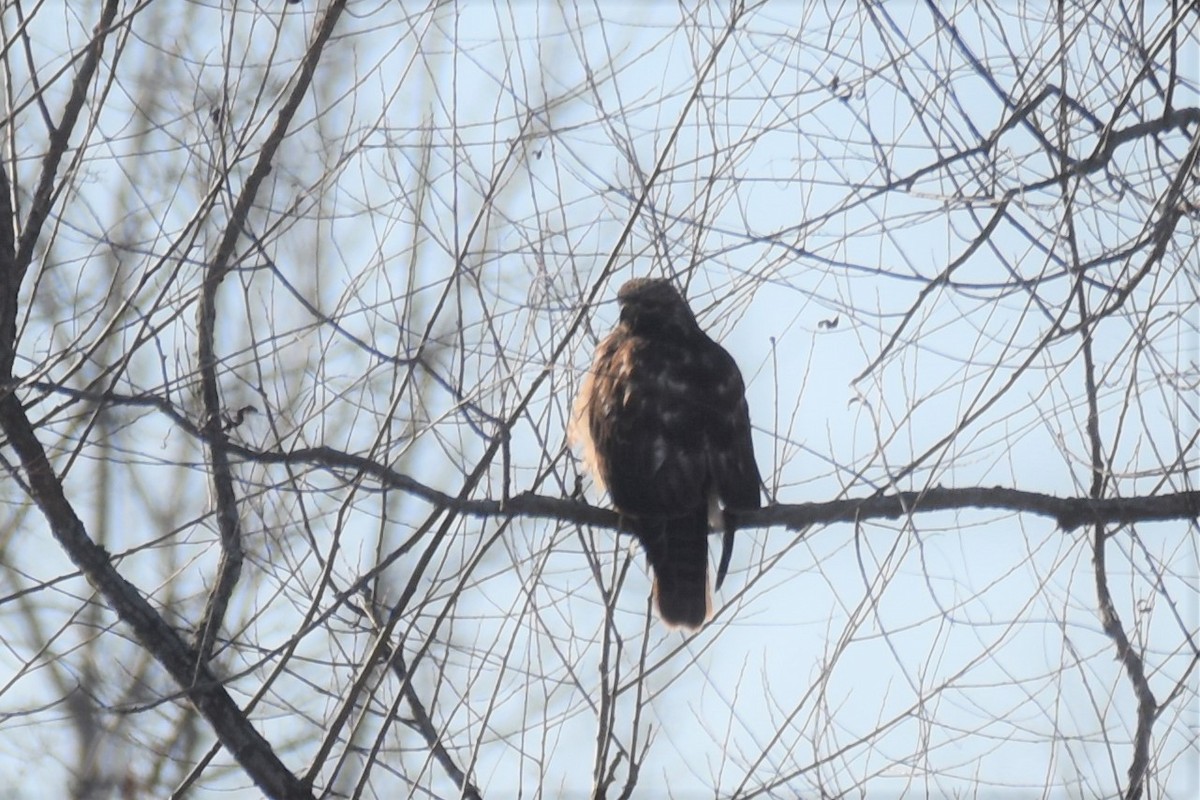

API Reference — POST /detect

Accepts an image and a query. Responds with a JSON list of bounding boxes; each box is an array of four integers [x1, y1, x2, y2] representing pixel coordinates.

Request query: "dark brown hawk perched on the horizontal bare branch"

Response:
[[572, 278, 760, 630]]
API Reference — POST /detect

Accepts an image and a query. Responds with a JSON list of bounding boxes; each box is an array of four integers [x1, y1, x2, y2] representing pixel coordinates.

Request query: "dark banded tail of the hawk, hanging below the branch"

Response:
[[630, 507, 713, 631]]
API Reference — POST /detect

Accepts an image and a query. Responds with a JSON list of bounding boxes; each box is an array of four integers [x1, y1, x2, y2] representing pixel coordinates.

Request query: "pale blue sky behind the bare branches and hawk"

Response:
[[0, 0, 1200, 798]]
